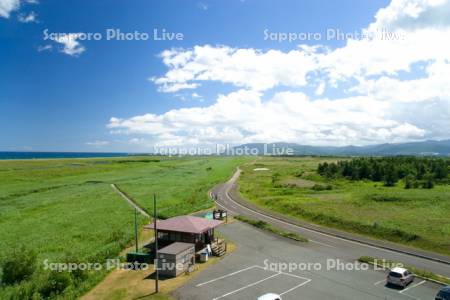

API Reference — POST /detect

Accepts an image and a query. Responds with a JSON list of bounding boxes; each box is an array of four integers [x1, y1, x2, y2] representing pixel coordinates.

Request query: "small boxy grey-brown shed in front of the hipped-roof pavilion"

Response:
[[158, 242, 195, 277]]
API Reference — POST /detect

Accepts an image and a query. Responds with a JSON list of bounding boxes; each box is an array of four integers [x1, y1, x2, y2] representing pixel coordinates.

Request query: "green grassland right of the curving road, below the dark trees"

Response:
[[239, 157, 450, 255]]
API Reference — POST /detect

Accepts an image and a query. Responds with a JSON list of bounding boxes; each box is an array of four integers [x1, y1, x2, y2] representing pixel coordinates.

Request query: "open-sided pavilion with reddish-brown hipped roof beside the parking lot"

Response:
[[144, 216, 223, 252]]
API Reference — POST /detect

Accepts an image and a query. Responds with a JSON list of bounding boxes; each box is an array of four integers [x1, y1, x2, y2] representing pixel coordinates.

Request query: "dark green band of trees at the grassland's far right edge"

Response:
[[317, 156, 450, 188]]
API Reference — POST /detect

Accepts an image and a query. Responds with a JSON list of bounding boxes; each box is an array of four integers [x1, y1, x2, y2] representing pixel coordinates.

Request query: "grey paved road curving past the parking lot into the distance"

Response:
[[212, 170, 450, 277]]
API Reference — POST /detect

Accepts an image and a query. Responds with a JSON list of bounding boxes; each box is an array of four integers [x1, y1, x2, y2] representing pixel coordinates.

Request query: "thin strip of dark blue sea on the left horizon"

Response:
[[0, 151, 129, 160]]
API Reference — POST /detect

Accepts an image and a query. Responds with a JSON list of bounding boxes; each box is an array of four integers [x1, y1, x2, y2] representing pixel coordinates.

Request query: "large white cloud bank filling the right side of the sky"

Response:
[[107, 0, 450, 145]]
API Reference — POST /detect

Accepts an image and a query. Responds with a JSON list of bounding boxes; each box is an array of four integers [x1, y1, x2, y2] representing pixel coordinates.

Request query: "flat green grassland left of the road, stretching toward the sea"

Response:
[[0, 157, 246, 299]]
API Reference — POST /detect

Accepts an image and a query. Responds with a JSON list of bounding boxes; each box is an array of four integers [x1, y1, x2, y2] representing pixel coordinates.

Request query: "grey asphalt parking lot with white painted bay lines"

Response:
[[174, 222, 441, 300]]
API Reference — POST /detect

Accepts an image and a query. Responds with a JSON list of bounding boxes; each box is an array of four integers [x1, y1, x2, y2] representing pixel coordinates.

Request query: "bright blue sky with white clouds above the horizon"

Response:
[[0, 0, 449, 152]]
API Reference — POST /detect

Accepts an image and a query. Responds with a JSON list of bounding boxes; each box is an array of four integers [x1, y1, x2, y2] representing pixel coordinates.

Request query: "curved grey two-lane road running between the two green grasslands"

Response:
[[211, 169, 450, 277]]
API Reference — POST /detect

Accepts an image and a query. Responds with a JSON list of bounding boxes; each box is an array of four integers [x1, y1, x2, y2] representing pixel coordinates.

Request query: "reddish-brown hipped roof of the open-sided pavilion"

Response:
[[145, 216, 222, 234]]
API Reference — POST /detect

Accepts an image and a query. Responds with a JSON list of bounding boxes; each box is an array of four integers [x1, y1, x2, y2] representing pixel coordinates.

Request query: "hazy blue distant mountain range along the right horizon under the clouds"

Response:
[[232, 140, 450, 156]]
